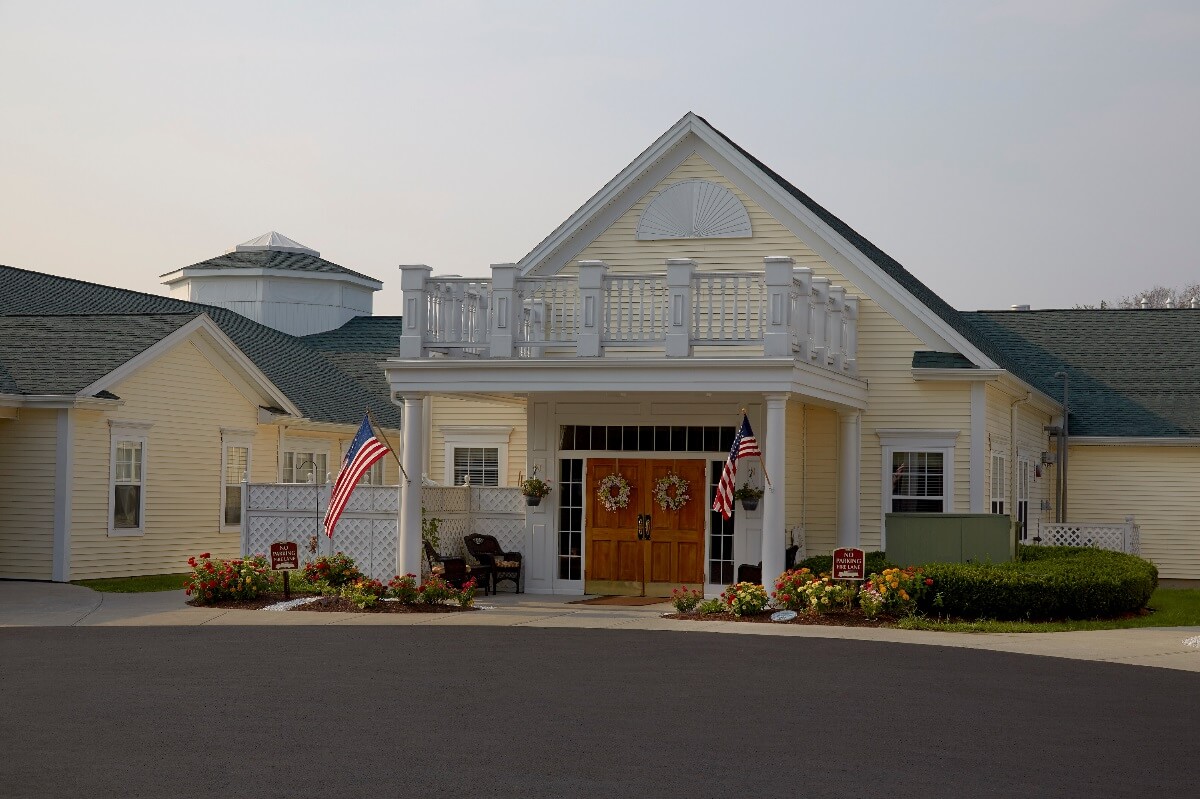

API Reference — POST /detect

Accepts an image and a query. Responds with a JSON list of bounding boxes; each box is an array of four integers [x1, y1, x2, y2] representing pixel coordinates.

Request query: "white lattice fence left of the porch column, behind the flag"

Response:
[[241, 483, 400, 581]]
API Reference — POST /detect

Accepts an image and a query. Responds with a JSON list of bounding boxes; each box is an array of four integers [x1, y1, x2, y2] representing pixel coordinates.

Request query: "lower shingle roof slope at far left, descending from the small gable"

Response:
[[0, 312, 199, 395]]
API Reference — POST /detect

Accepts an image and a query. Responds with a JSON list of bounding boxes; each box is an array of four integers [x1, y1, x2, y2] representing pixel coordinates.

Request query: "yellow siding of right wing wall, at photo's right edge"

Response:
[[1067, 446, 1200, 579]]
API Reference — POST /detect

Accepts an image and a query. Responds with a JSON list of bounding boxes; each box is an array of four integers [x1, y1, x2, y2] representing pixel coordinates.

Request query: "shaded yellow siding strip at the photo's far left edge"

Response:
[[0, 409, 59, 579]]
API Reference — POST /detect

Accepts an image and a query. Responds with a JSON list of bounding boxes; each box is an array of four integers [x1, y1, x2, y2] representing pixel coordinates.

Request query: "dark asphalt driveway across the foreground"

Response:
[[0, 625, 1200, 798]]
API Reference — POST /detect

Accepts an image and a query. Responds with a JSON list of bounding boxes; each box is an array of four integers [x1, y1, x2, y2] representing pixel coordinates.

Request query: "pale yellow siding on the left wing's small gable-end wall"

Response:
[[71, 341, 274, 579]]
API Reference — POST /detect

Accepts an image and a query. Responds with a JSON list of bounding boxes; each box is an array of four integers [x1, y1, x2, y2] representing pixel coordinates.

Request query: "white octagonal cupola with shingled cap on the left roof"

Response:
[[162, 230, 383, 336]]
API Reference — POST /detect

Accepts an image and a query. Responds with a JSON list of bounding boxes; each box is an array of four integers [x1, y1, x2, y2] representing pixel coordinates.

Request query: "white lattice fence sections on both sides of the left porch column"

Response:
[[241, 483, 524, 581]]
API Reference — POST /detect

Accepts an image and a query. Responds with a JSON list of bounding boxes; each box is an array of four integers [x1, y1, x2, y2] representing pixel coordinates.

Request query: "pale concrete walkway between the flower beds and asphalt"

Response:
[[0, 581, 1200, 672]]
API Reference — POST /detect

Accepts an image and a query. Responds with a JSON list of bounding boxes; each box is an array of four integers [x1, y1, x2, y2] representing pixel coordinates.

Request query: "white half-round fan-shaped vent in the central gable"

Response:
[[637, 180, 752, 241]]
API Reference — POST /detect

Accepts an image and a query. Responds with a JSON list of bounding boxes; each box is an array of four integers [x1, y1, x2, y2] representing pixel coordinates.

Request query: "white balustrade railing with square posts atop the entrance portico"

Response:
[[401, 257, 858, 374]]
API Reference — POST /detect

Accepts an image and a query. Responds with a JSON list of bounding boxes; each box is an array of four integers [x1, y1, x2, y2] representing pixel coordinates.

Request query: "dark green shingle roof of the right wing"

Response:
[[962, 308, 1200, 438]]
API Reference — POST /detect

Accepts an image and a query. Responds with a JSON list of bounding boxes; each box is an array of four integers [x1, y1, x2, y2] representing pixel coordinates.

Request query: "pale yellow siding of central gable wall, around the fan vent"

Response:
[[576, 155, 971, 552]]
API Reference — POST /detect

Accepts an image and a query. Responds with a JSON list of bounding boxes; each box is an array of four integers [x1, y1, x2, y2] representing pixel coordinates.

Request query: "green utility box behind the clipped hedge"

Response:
[[886, 513, 1016, 566]]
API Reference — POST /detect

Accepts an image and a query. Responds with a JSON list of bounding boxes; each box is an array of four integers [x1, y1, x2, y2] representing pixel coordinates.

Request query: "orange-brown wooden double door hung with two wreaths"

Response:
[[583, 458, 708, 596]]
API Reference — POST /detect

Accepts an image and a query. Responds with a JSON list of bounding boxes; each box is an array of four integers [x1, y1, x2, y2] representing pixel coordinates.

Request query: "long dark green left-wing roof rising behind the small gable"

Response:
[[0, 262, 400, 427]]
